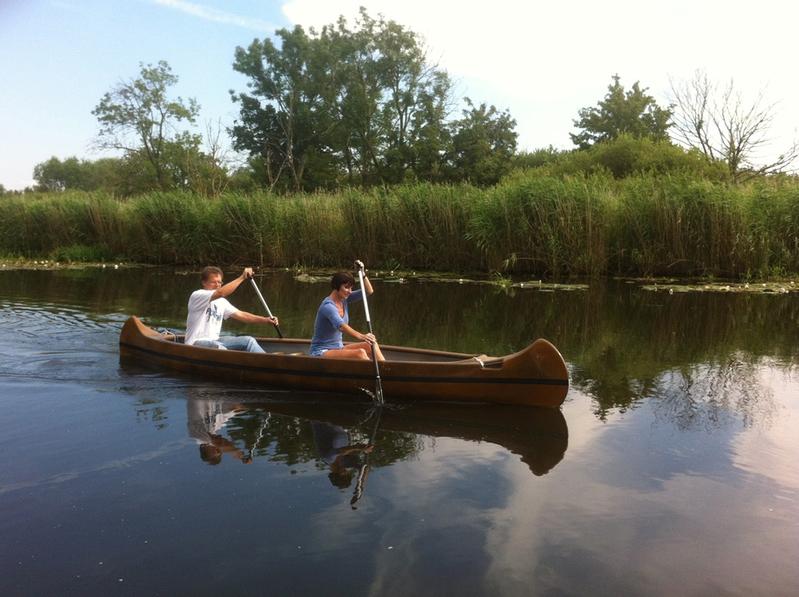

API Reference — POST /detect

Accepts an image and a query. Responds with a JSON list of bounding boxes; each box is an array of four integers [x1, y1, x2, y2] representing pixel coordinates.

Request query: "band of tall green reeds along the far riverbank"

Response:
[[0, 171, 799, 278]]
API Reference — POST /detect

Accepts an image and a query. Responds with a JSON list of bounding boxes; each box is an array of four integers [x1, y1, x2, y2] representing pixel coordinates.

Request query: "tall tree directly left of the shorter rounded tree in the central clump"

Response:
[[330, 9, 451, 184]]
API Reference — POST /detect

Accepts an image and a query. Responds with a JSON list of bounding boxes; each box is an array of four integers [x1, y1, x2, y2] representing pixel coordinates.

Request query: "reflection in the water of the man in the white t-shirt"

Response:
[[186, 398, 252, 464]]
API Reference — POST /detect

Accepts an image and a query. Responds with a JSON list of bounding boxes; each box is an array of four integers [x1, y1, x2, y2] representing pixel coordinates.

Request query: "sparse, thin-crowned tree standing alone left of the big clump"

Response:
[[92, 60, 200, 190]]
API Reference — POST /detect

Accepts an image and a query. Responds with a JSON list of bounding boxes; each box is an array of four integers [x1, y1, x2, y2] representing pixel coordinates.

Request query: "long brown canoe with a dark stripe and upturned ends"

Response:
[[119, 317, 569, 407]]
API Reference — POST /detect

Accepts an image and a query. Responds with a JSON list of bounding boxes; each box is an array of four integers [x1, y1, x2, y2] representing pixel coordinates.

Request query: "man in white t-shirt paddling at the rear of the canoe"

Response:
[[185, 266, 278, 352]]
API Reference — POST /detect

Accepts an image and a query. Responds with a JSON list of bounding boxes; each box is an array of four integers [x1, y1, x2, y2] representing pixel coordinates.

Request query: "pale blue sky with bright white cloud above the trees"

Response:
[[0, 0, 799, 189]]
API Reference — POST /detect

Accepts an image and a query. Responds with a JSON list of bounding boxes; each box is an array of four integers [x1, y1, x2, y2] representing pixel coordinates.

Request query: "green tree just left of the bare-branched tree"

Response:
[[569, 75, 672, 149]]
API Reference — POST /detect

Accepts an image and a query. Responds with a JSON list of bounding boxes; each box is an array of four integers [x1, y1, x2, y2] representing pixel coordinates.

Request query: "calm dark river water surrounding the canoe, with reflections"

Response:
[[0, 269, 799, 595]]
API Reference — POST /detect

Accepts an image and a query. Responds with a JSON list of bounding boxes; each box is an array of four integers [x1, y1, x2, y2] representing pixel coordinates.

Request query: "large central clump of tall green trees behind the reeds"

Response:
[[231, 9, 516, 191]]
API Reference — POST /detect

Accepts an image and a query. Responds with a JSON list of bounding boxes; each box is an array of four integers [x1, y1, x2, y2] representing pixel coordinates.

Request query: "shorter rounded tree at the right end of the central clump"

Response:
[[450, 98, 517, 186]]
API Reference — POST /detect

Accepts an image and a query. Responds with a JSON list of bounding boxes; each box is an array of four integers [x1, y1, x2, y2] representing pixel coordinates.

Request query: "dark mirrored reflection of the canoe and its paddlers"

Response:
[[178, 389, 568, 480]]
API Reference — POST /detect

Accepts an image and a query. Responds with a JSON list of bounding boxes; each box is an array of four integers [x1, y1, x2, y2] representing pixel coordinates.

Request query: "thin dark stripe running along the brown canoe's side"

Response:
[[120, 342, 569, 386]]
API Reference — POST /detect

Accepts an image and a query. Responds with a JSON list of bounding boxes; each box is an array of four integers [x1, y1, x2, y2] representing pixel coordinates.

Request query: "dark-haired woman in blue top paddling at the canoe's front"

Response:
[[310, 272, 385, 361]]
